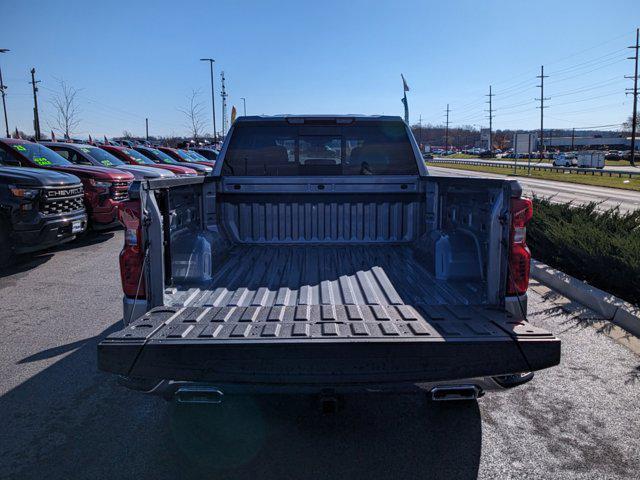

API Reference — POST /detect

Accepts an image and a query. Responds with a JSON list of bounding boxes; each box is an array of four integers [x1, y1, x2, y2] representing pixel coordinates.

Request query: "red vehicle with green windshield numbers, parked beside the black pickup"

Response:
[[0, 138, 133, 230]]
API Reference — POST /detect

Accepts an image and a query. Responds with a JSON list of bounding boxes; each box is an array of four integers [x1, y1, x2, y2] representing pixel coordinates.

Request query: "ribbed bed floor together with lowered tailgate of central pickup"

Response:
[[99, 245, 560, 385]]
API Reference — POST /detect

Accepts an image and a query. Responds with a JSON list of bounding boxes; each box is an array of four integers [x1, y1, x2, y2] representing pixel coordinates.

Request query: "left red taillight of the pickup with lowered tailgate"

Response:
[[118, 200, 145, 298]]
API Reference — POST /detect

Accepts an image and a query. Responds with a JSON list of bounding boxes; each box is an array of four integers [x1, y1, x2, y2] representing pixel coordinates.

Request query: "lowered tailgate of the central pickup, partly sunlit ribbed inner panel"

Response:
[[98, 305, 560, 384]]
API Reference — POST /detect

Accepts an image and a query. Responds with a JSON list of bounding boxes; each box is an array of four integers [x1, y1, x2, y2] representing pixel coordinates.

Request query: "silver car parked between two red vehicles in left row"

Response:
[[40, 142, 175, 182]]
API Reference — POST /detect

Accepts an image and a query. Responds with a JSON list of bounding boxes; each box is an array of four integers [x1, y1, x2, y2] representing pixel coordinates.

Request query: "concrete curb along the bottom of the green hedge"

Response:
[[531, 259, 640, 338]]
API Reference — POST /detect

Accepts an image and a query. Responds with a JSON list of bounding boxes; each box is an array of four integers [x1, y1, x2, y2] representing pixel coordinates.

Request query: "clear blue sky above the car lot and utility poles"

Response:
[[0, 0, 640, 137]]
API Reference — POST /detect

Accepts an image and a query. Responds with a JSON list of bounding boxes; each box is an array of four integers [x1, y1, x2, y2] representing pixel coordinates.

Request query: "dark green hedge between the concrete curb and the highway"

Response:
[[527, 198, 640, 305]]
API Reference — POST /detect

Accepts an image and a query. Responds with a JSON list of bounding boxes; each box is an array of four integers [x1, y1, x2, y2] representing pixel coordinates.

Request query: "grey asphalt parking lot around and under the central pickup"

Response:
[[0, 231, 640, 479]]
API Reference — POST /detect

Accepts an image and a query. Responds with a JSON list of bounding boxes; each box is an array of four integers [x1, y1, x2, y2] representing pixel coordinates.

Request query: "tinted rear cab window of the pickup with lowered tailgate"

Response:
[[222, 122, 418, 176]]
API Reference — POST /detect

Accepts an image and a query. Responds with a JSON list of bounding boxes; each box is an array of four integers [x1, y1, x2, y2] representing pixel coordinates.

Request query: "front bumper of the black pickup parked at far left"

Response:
[[12, 211, 87, 253]]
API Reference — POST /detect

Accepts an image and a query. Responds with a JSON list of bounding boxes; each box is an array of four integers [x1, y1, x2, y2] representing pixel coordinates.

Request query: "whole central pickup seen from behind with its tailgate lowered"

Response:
[[98, 116, 560, 403]]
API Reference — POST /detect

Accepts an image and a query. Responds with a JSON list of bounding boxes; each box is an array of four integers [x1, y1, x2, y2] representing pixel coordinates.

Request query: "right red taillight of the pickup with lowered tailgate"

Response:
[[507, 198, 533, 295]]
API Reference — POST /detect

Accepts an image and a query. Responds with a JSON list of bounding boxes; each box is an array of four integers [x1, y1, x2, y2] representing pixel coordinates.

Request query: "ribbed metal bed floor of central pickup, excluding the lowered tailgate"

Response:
[[166, 244, 482, 307]]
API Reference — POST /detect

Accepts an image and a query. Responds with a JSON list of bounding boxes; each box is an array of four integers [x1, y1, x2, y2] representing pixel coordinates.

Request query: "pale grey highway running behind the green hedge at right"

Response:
[[427, 164, 640, 211]]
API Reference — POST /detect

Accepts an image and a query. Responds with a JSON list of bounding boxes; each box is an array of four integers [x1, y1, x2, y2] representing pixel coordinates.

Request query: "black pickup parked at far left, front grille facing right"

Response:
[[0, 166, 87, 266]]
